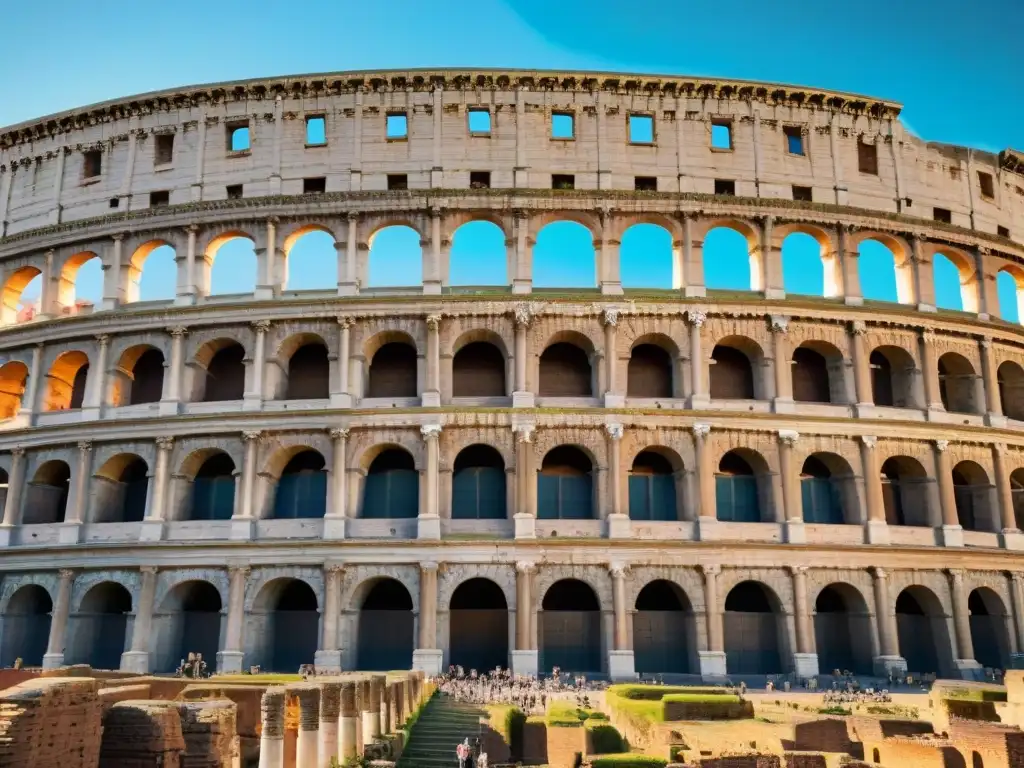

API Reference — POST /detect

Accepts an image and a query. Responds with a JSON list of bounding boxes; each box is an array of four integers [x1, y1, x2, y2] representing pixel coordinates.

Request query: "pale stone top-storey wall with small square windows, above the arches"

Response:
[[0, 72, 1024, 242]]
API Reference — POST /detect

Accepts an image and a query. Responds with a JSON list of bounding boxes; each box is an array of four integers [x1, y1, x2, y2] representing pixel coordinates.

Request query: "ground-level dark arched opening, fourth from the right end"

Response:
[[724, 582, 785, 675]]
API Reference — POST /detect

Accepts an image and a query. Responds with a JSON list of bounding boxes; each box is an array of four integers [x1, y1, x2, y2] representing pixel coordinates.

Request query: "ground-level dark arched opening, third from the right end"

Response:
[[814, 584, 871, 675]]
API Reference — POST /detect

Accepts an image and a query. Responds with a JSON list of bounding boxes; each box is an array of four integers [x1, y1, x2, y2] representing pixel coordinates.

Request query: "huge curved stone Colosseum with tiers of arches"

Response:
[[0, 70, 1024, 680]]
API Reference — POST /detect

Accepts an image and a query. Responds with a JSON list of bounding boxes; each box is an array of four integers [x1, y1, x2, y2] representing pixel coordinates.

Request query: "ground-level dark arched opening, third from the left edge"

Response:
[[154, 581, 223, 673]]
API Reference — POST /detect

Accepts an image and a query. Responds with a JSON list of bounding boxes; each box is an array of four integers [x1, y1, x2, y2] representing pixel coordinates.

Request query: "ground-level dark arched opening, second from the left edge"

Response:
[[65, 582, 132, 670]]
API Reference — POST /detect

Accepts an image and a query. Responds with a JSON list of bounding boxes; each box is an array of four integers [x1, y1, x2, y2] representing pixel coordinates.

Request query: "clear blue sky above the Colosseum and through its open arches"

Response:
[[0, 0, 1024, 317]]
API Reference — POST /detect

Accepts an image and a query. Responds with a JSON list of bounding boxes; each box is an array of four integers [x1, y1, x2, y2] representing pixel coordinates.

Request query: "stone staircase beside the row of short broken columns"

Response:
[[397, 693, 486, 768]]
